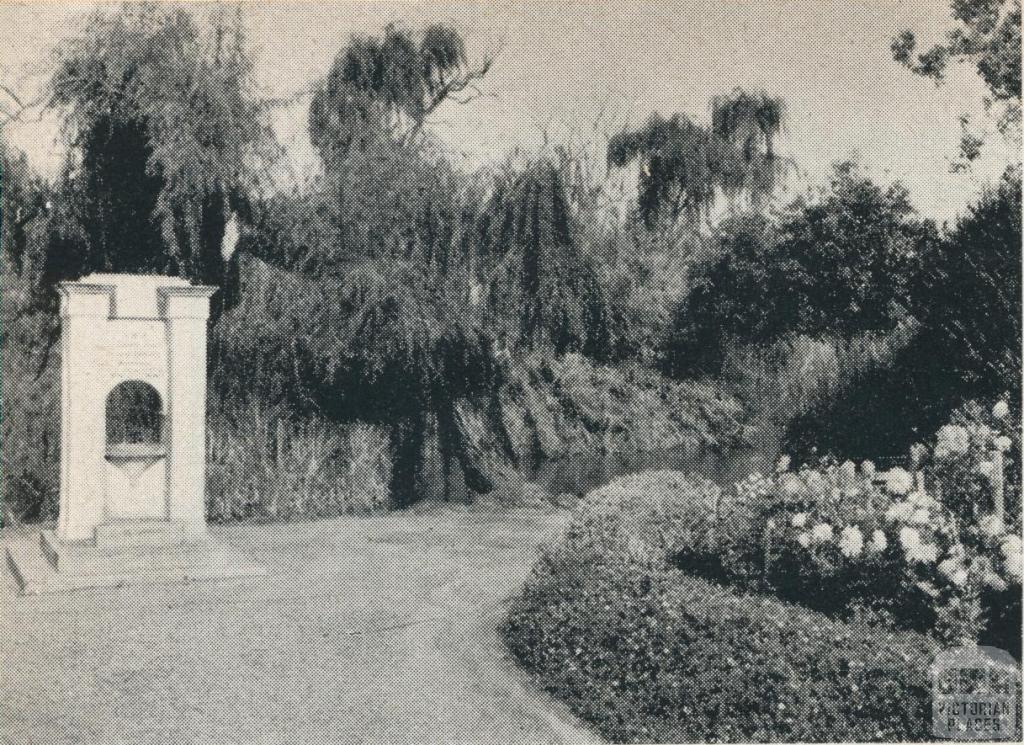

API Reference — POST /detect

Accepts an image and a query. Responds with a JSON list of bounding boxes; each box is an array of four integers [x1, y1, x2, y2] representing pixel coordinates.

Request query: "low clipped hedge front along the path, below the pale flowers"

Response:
[[504, 543, 938, 742]]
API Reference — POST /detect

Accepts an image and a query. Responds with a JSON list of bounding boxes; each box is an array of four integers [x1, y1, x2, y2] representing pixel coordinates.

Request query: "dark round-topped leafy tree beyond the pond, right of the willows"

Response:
[[664, 163, 935, 376]]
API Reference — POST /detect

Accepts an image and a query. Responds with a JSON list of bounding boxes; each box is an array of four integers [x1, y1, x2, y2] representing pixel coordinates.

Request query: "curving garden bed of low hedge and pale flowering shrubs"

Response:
[[504, 442, 1021, 742]]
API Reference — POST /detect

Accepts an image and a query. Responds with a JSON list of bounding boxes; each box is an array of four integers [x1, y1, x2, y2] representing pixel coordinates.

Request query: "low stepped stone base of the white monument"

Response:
[[6, 521, 266, 595]]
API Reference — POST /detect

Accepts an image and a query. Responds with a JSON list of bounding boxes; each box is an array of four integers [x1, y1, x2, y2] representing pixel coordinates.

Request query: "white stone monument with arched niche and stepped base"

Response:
[[7, 274, 262, 593]]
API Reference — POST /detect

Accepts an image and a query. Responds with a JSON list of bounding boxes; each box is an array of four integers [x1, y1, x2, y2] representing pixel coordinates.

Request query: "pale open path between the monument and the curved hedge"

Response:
[[0, 508, 596, 745]]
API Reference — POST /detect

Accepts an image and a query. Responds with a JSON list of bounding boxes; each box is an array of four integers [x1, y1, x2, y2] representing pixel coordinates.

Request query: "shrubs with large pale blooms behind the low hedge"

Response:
[[708, 395, 1024, 654]]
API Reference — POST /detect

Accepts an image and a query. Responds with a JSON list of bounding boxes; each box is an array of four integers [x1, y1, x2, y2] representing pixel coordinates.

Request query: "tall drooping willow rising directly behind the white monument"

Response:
[[49, 3, 273, 298]]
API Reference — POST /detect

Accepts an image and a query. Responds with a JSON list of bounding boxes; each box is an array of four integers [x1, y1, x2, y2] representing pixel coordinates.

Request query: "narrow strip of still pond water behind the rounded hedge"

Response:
[[528, 438, 778, 495]]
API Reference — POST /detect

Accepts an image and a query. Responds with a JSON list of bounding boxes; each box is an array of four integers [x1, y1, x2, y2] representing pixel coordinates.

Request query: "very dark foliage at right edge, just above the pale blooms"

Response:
[[785, 170, 1021, 457]]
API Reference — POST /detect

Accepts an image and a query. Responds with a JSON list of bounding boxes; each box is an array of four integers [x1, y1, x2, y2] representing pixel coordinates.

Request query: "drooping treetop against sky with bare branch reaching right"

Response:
[[309, 24, 490, 162]]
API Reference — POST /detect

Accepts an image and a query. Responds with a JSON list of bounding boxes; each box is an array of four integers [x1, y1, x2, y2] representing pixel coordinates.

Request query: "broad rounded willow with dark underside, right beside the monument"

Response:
[[213, 254, 499, 507]]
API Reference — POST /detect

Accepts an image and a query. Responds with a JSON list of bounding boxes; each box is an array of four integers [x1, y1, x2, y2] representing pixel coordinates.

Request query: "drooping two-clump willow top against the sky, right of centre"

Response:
[[607, 89, 787, 227]]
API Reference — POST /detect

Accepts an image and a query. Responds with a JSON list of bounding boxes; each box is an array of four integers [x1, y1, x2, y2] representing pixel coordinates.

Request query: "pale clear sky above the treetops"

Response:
[[0, 0, 1019, 220]]
